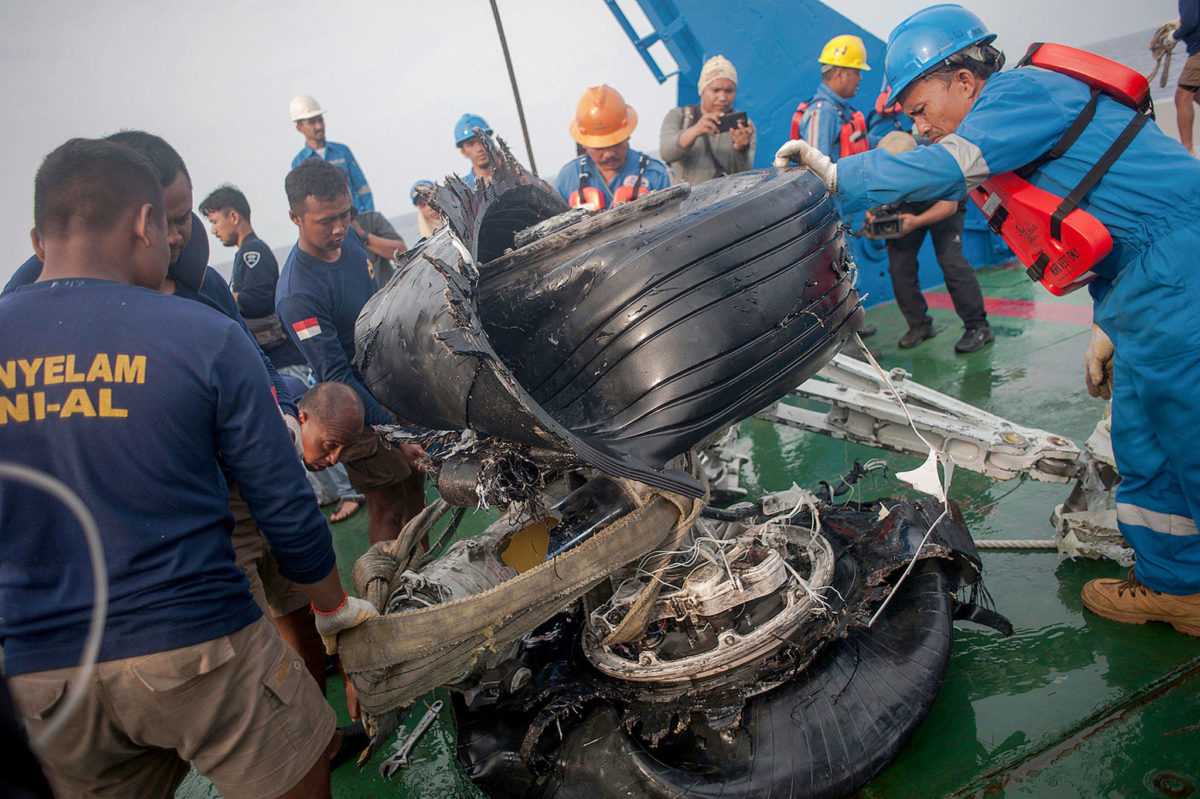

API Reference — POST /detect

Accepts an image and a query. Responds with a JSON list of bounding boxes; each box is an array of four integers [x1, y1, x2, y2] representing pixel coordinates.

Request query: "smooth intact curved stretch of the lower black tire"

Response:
[[542, 560, 954, 799]]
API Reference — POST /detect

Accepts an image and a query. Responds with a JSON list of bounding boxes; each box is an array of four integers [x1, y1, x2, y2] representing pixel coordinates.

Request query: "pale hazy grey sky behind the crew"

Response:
[[0, 0, 1176, 281]]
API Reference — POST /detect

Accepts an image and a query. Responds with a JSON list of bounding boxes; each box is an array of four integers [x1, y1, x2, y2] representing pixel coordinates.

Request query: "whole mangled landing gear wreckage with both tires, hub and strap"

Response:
[[340, 143, 1010, 799]]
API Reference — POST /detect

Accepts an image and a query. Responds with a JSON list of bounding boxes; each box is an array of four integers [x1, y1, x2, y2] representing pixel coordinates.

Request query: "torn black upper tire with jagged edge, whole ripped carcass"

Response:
[[356, 155, 863, 495]]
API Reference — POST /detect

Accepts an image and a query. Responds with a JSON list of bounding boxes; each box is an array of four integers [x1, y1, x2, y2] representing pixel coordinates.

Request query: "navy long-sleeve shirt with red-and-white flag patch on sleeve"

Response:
[[275, 235, 396, 425]]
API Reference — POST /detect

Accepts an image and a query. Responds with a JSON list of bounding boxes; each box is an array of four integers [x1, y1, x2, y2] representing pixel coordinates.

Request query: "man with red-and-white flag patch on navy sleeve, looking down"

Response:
[[275, 158, 425, 542]]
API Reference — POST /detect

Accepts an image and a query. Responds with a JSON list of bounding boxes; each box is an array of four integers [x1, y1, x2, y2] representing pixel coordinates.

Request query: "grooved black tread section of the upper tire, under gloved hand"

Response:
[[478, 165, 862, 464]]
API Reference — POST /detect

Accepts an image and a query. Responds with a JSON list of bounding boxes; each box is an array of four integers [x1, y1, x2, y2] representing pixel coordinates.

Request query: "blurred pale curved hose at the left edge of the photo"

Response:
[[0, 462, 108, 749]]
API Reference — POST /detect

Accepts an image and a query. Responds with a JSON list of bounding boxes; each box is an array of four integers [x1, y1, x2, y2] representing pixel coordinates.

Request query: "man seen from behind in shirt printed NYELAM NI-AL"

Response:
[[0, 139, 374, 799]]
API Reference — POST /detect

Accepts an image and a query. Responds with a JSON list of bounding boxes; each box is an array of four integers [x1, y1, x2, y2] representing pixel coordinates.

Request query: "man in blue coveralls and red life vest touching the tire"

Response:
[[776, 5, 1200, 636]]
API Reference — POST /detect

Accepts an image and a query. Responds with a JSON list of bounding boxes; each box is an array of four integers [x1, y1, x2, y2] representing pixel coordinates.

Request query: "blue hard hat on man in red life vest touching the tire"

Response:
[[883, 2, 996, 100]]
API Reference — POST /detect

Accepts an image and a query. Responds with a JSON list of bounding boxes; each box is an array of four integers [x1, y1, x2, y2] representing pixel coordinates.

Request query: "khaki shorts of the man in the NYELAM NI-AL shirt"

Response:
[[8, 619, 336, 799]]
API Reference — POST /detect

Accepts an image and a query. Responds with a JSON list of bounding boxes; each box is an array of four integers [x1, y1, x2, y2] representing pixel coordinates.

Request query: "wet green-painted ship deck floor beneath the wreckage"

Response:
[[179, 262, 1200, 799]]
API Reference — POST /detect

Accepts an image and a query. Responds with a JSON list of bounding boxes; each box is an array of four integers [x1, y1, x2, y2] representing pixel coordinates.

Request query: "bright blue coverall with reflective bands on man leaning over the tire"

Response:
[[838, 67, 1200, 595]]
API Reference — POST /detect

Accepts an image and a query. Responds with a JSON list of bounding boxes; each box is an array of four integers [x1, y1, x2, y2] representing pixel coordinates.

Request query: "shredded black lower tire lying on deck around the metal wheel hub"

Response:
[[458, 500, 993, 799]]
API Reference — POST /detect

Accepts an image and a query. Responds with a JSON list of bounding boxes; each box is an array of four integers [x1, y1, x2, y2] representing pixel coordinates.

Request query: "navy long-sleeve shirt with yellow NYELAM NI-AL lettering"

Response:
[[0, 280, 334, 674]]
